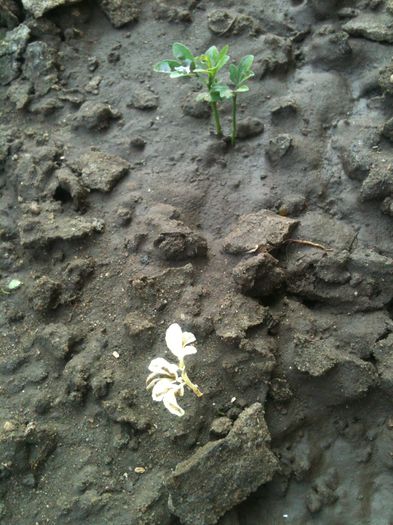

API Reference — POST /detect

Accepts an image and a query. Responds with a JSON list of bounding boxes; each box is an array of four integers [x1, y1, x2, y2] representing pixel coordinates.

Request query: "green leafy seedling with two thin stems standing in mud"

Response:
[[154, 42, 254, 145]]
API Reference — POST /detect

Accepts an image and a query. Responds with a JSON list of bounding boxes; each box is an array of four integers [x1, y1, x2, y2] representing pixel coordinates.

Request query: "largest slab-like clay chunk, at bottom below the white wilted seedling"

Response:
[[168, 403, 277, 525]]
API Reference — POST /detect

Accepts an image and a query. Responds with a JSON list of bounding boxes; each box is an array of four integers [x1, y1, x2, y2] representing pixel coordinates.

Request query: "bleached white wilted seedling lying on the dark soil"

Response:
[[146, 323, 203, 417]]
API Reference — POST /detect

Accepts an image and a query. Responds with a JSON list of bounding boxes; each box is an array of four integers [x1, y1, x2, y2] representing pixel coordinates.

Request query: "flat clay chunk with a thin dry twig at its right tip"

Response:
[[224, 210, 299, 254]]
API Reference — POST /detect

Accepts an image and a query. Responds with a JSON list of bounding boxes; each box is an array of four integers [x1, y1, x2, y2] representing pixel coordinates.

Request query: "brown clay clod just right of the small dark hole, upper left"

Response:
[[79, 151, 130, 192]]
